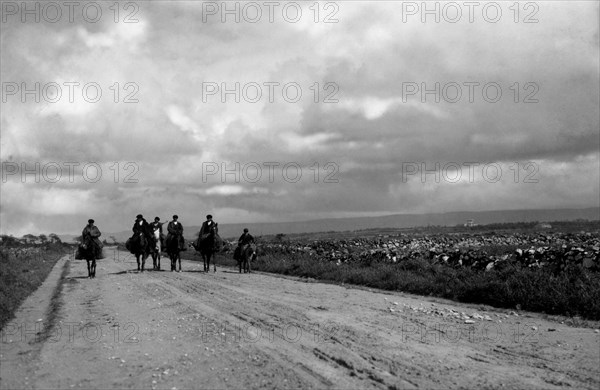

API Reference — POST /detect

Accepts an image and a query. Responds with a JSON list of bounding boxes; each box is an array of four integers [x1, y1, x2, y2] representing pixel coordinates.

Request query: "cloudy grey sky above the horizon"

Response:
[[0, 1, 600, 236]]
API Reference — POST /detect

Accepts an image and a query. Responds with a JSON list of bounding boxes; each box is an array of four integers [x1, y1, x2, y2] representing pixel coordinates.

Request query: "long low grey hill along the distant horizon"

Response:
[[95, 207, 600, 242]]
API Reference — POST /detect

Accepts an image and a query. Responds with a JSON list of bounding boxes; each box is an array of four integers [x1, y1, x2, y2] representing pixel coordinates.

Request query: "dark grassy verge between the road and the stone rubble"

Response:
[[252, 253, 600, 320]]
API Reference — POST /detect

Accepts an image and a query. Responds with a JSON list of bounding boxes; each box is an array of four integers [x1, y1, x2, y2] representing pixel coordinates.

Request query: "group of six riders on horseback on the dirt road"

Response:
[[80, 214, 256, 278]]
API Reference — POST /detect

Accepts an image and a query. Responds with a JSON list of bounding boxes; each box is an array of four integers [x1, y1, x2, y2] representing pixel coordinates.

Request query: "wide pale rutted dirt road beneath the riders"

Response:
[[0, 252, 600, 389]]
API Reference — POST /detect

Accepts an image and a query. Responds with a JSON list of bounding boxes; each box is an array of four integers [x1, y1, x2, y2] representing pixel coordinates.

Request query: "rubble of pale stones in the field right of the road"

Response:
[[262, 232, 600, 272]]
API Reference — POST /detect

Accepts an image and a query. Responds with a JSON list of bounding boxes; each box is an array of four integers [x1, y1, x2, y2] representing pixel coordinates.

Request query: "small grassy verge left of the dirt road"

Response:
[[0, 244, 72, 329]]
